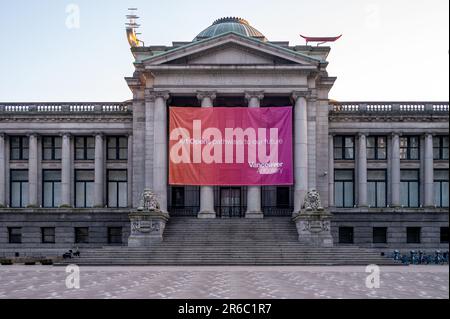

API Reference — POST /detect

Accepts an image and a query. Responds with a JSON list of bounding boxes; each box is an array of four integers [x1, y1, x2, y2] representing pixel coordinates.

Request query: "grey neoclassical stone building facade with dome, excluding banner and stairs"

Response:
[[0, 18, 449, 251]]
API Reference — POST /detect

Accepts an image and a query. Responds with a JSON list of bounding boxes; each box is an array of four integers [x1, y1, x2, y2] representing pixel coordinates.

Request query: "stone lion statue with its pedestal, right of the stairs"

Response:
[[293, 190, 333, 247]]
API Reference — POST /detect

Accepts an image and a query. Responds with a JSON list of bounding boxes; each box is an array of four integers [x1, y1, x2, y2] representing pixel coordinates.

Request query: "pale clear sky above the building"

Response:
[[0, 0, 449, 102]]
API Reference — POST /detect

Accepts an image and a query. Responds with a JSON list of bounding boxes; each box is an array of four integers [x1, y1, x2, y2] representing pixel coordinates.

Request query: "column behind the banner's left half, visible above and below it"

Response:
[[197, 92, 216, 218]]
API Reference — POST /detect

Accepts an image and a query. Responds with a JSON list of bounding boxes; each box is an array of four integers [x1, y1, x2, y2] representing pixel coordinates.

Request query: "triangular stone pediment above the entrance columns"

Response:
[[142, 33, 324, 68]]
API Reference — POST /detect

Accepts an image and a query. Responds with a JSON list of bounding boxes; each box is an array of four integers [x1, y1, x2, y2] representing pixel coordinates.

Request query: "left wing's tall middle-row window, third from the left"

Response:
[[75, 170, 95, 208]]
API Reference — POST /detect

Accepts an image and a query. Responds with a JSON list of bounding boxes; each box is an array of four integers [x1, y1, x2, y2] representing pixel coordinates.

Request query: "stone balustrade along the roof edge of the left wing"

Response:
[[0, 102, 131, 114]]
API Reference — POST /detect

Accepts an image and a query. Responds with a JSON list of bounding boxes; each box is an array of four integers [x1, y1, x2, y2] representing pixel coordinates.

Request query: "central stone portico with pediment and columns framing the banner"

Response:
[[127, 25, 334, 218]]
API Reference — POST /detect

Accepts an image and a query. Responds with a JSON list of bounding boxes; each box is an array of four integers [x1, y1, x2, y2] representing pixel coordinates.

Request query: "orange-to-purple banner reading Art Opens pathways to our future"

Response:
[[169, 107, 293, 186]]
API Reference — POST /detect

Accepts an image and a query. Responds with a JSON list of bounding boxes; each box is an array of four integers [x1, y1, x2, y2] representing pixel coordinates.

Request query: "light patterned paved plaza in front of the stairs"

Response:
[[0, 266, 449, 299]]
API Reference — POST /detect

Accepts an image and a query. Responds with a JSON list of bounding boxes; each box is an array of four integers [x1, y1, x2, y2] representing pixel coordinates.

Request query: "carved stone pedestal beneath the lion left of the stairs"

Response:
[[128, 211, 169, 247]]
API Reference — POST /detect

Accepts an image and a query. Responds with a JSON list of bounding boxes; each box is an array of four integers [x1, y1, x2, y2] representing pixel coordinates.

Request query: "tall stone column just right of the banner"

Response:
[[292, 92, 308, 214]]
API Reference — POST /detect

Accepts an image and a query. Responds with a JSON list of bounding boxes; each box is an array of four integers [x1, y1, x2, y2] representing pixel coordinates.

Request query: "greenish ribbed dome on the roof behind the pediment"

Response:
[[194, 17, 267, 42]]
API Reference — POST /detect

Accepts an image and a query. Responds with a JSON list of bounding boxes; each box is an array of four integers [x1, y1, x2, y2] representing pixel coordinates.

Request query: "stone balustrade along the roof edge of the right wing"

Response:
[[329, 102, 449, 114]]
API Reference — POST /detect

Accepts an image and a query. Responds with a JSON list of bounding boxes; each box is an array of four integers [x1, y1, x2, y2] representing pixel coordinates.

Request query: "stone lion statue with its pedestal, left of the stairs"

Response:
[[128, 189, 169, 247]]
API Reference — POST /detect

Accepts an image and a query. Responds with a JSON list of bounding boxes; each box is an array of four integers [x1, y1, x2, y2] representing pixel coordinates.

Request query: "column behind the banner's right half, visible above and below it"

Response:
[[245, 91, 264, 218]]
